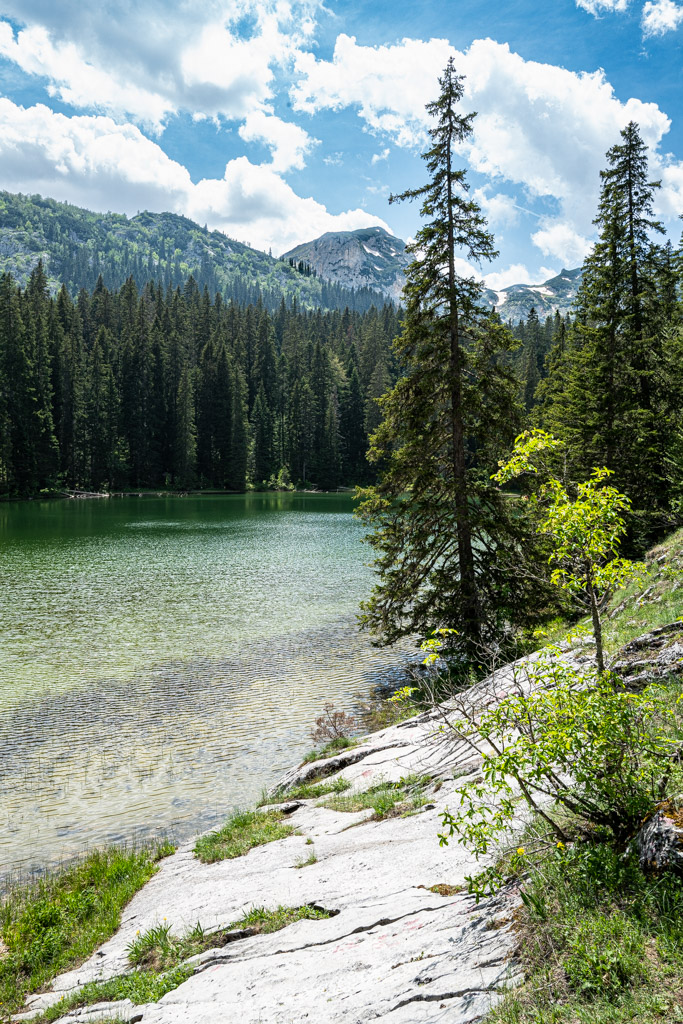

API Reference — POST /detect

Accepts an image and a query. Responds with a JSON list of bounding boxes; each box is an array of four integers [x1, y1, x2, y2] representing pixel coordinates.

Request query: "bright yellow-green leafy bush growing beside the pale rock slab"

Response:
[[440, 655, 679, 887]]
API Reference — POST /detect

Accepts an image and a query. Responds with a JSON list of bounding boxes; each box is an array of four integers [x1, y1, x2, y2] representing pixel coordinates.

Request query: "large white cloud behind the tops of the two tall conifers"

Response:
[[292, 35, 677, 264]]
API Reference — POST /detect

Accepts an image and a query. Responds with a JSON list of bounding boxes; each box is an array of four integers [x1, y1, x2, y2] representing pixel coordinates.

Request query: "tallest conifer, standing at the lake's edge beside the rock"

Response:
[[360, 59, 536, 658]]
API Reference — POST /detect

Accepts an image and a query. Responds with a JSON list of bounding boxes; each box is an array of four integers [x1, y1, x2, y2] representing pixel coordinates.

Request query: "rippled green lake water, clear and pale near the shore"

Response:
[[0, 495, 412, 874]]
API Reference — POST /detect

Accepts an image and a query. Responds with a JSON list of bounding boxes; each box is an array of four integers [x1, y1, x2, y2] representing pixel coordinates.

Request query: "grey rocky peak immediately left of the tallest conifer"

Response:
[[282, 227, 411, 303]]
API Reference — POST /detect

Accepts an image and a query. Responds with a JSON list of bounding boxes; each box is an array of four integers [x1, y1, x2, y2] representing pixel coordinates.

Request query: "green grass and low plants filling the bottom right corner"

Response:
[[487, 835, 683, 1024]]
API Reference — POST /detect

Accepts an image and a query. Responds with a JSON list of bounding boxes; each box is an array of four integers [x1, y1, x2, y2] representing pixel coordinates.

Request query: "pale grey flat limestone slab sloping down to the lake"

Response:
[[26, 657, 552, 1024]]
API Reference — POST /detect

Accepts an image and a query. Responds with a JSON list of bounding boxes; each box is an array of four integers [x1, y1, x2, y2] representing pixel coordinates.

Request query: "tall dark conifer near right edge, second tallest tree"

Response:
[[543, 122, 675, 539]]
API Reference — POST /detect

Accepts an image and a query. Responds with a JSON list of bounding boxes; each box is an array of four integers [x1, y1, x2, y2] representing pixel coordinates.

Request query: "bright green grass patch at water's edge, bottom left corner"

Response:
[[0, 843, 175, 1020]]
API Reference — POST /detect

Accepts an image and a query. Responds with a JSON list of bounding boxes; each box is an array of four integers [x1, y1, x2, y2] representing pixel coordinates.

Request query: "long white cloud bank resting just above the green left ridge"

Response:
[[0, 98, 388, 252]]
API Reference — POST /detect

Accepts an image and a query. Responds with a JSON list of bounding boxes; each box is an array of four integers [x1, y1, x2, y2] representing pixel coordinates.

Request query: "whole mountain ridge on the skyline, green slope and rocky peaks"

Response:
[[0, 191, 582, 322]]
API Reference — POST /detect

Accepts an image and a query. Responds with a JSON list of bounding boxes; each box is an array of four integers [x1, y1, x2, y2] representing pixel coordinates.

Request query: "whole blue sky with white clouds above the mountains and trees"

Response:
[[0, 0, 683, 288]]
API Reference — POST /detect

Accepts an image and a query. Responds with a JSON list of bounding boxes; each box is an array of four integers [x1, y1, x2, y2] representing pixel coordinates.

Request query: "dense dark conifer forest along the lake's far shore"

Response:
[[0, 263, 398, 496]]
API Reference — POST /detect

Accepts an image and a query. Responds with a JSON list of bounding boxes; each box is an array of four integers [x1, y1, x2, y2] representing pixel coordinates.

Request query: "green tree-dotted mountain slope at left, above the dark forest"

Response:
[[0, 191, 386, 312]]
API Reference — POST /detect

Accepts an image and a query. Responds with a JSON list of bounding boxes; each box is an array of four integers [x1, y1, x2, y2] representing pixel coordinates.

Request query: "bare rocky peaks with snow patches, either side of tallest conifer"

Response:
[[282, 227, 582, 322]]
